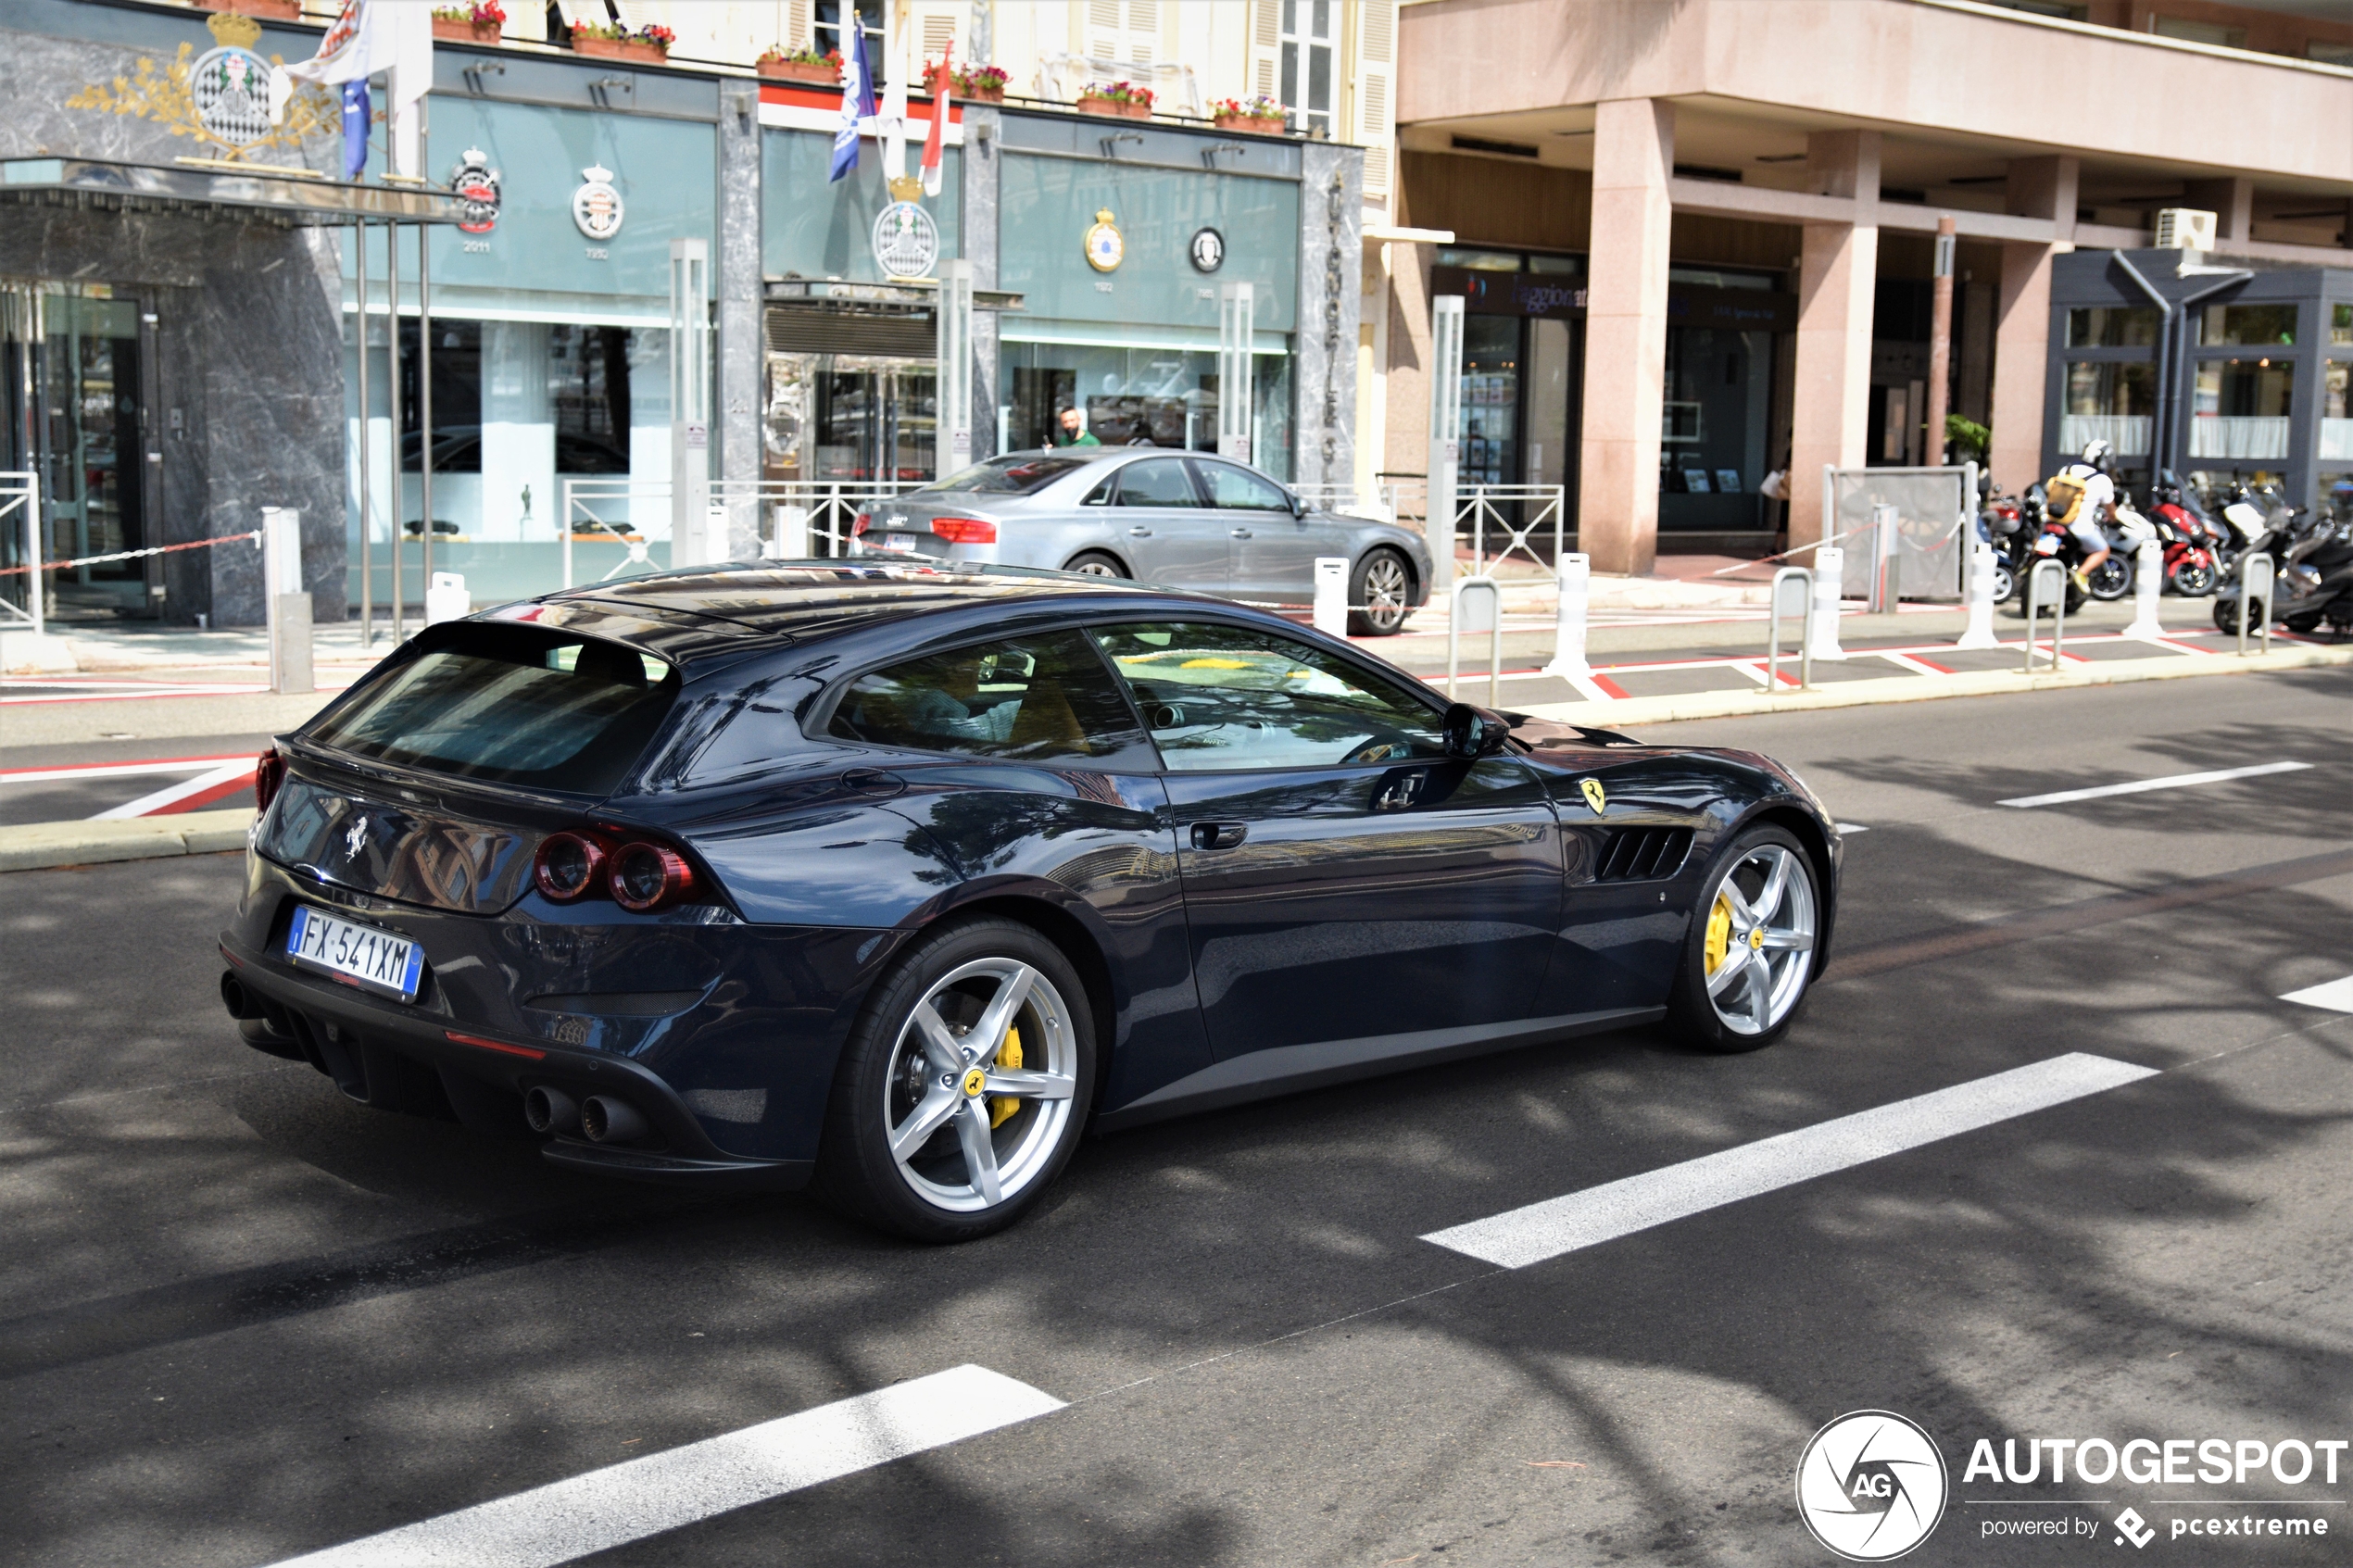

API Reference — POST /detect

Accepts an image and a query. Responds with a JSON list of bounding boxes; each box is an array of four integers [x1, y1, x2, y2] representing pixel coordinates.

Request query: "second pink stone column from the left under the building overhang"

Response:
[[1788, 132, 1880, 547]]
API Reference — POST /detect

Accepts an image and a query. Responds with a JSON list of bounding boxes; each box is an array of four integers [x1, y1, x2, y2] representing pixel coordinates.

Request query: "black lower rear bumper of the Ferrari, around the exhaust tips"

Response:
[[221, 934, 816, 1192]]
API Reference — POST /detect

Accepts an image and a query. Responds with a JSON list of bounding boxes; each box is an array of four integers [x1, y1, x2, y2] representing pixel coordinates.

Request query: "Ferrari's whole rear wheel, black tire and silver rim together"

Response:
[[816, 919, 1094, 1241]]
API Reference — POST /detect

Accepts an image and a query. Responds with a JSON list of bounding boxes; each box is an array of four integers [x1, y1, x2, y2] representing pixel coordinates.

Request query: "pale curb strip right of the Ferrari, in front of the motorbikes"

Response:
[[1520, 646, 2353, 726]]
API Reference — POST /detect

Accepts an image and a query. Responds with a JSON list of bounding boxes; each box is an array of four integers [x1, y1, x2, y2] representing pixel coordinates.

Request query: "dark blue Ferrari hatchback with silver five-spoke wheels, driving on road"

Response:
[[221, 562, 1840, 1241]]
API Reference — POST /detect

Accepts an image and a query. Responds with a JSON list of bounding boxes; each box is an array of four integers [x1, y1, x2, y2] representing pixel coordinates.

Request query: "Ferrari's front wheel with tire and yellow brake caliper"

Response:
[[1668, 827, 1821, 1051]]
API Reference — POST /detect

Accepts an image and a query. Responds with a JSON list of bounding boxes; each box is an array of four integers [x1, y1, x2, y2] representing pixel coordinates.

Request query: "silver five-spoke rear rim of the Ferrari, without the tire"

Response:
[[880, 957, 1077, 1213]]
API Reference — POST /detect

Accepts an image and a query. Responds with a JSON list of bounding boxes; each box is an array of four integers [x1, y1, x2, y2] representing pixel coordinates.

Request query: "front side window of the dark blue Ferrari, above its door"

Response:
[[1094, 625, 1445, 773]]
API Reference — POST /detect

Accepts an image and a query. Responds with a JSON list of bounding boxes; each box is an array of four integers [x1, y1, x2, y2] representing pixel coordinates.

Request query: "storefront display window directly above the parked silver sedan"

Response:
[[1000, 344, 1291, 480]]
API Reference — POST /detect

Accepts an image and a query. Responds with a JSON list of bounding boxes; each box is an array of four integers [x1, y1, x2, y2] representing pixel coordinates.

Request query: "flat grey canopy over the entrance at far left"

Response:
[[0, 157, 466, 228]]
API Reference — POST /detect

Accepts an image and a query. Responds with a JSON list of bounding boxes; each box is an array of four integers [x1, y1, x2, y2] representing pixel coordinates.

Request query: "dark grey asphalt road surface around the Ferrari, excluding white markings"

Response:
[[0, 670, 2353, 1568]]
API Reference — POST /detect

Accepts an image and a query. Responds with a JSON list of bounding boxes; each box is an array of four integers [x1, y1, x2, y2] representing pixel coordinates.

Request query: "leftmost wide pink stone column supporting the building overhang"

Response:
[[1577, 99, 1675, 573]]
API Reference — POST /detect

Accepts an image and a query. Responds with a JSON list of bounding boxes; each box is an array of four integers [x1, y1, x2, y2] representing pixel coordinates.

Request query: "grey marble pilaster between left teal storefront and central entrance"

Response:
[[711, 82, 767, 559]]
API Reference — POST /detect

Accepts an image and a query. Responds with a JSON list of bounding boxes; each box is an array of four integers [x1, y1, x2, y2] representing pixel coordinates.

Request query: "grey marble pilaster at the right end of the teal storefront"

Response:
[[1291, 141, 1365, 484]]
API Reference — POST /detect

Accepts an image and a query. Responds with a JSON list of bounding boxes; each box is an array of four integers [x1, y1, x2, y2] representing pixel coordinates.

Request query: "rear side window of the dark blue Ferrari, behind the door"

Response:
[[828, 633, 1151, 766]]
